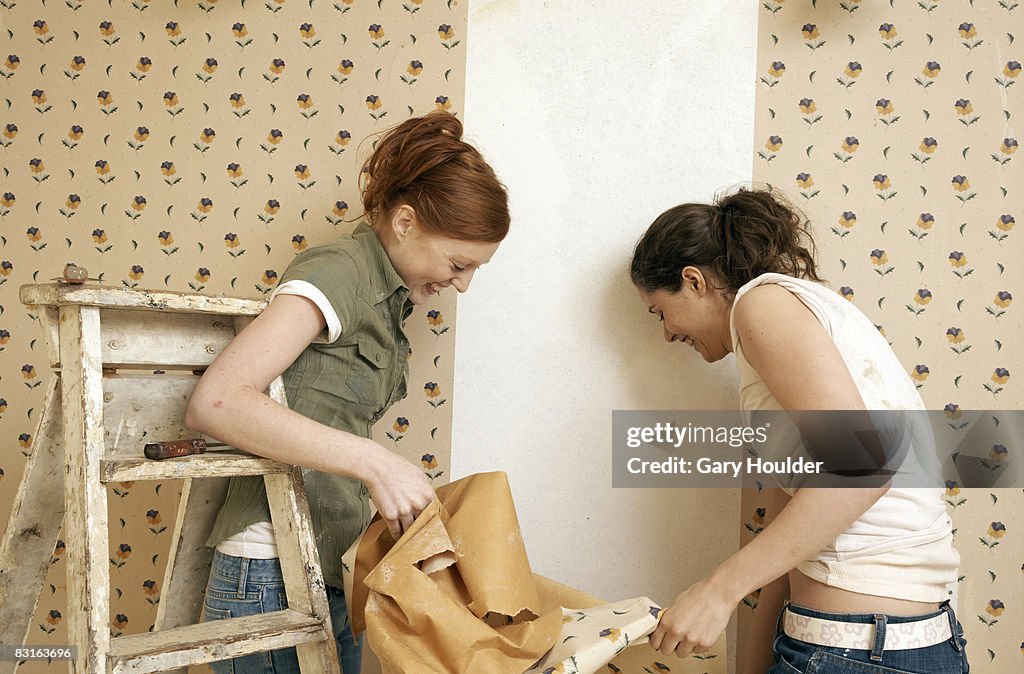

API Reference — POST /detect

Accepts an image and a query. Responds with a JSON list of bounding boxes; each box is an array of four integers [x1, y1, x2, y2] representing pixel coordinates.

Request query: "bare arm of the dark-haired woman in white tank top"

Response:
[[651, 285, 888, 657]]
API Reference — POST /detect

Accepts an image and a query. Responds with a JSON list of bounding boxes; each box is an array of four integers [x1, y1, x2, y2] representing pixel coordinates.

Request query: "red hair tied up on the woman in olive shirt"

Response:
[[361, 111, 510, 242]]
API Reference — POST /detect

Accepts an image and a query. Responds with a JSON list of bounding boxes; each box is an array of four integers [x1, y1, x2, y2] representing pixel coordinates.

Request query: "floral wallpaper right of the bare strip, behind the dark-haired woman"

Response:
[[740, 0, 1024, 673]]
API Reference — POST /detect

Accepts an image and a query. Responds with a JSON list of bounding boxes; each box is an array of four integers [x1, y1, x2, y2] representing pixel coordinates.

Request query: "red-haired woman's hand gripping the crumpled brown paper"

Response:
[[364, 440, 435, 541]]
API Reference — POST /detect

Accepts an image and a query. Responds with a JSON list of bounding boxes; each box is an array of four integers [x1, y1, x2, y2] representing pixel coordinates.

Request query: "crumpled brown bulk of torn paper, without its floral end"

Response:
[[346, 472, 562, 674]]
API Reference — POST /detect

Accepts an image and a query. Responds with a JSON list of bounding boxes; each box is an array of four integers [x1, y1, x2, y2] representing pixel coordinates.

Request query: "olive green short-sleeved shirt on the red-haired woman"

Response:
[[207, 224, 412, 588]]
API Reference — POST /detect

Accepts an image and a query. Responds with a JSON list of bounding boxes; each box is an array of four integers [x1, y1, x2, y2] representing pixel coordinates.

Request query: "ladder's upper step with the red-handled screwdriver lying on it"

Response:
[[99, 452, 292, 482]]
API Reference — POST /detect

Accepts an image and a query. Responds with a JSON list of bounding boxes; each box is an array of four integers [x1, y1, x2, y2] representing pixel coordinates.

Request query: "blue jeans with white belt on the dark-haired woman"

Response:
[[768, 601, 971, 674]]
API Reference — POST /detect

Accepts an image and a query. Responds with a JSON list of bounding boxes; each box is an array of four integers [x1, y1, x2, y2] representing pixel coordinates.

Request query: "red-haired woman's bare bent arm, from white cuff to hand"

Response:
[[185, 295, 434, 538]]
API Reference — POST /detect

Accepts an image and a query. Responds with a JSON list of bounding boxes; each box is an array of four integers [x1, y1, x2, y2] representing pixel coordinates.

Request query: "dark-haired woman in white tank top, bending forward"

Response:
[[631, 189, 968, 674]]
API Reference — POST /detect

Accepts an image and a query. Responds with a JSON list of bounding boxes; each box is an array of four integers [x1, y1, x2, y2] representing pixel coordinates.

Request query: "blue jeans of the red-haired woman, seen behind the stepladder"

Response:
[[203, 551, 362, 674]]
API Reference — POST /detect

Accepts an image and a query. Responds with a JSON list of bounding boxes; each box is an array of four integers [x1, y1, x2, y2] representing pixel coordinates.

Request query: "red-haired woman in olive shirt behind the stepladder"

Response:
[[186, 113, 509, 674]]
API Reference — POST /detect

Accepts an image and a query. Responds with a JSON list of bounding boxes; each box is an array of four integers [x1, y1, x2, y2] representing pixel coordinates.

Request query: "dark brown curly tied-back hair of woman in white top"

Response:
[[630, 187, 821, 296]]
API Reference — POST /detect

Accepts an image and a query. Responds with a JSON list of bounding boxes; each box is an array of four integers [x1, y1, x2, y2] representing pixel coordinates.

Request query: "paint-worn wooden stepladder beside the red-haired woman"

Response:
[[0, 284, 340, 674]]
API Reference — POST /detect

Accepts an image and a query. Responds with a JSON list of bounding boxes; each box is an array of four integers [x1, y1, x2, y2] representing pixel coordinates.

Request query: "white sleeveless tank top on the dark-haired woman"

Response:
[[729, 273, 959, 601]]
